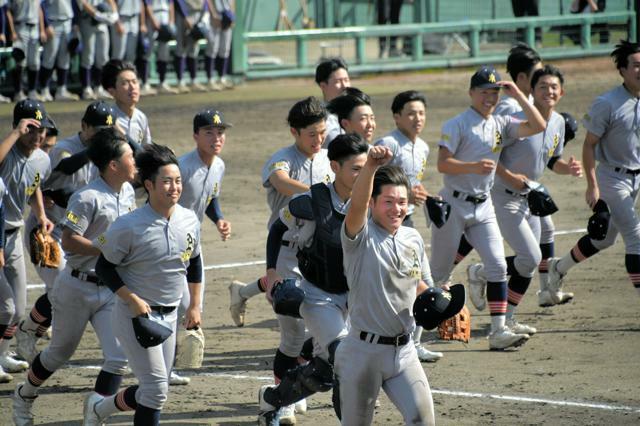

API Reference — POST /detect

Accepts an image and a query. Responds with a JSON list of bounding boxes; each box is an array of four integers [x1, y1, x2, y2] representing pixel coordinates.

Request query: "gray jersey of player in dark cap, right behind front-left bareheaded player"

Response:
[[178, 150, 225, 222]]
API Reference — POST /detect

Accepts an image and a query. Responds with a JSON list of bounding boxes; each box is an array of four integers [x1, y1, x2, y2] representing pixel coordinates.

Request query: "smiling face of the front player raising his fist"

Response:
[[369, 184, 409, 234]]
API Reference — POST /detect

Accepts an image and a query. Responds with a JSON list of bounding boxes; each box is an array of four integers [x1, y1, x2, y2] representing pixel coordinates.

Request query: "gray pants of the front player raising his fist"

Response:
[[335, 330, 435, 426]]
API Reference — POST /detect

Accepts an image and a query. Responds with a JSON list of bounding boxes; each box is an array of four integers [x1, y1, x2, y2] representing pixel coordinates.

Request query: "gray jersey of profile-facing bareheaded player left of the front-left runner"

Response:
[[61, 177, 136, 272]]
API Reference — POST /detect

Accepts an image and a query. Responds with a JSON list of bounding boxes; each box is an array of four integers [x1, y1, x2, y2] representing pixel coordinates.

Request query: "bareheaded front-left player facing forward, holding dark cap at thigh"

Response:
[[89, 144, 202, 426]]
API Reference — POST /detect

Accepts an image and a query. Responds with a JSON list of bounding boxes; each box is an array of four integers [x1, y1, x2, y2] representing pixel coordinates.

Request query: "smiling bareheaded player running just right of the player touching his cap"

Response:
[[469, 65, 582, 336]]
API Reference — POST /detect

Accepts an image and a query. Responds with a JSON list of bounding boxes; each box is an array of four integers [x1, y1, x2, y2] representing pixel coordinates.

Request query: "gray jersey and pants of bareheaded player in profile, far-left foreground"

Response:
[[40, 177, 135, 375]]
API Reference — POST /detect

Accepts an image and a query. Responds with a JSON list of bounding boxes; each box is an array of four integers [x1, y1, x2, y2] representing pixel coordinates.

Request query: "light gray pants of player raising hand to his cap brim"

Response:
[[429, 188, 507, 284]]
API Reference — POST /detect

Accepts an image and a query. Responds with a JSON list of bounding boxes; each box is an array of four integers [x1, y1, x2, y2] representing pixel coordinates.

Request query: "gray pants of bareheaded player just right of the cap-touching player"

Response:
[[491, 188, 542, 278]]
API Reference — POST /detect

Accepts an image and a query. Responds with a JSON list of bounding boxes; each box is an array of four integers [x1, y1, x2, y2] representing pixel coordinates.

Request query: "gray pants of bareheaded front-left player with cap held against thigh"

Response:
[[111, 298, 178, 410]]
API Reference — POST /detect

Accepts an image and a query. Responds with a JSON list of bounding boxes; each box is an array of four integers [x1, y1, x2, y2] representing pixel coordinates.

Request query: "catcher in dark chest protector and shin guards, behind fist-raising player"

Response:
[[259, 134, 369, 423]]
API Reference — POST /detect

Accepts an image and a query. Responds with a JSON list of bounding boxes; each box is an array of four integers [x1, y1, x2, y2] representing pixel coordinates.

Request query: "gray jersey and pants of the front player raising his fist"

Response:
[[335, 219, 435, 426]]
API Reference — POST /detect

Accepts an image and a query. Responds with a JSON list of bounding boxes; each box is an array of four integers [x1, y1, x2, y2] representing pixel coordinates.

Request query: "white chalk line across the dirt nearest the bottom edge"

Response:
[[69, 365, 640, 413]]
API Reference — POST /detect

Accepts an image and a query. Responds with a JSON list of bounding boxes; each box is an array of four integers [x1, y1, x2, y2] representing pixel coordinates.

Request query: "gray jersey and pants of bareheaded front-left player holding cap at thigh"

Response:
[[96, 204, 200, 410]]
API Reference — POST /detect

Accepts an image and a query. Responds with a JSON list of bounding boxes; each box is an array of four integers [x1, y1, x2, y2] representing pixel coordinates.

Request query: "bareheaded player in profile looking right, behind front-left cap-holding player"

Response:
[[13, 127, 136, 425]]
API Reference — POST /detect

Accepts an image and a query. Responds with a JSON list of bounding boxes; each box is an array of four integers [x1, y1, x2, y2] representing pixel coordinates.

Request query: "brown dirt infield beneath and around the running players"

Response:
[[0, 59, 640, 425]]
